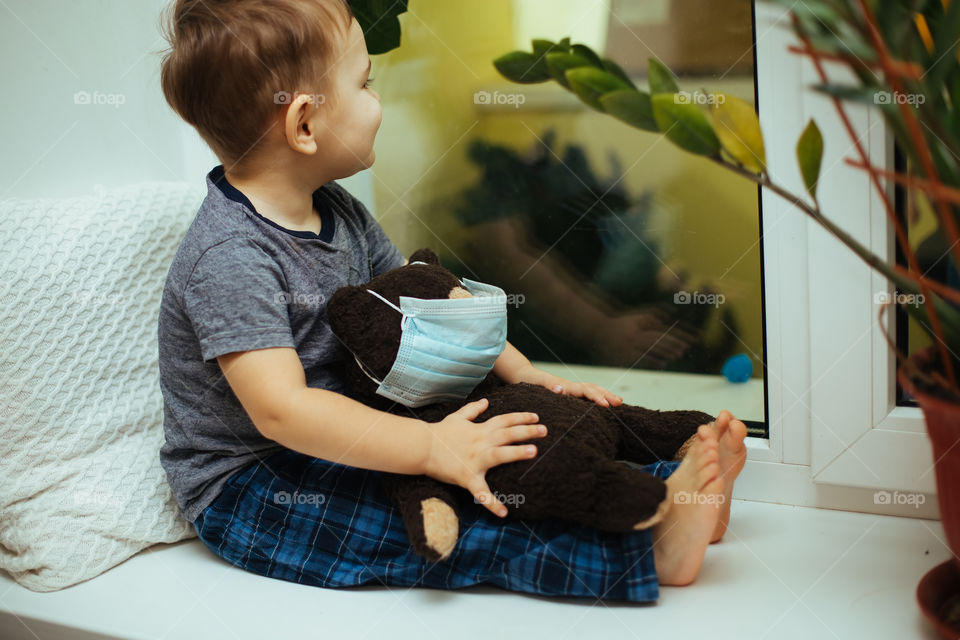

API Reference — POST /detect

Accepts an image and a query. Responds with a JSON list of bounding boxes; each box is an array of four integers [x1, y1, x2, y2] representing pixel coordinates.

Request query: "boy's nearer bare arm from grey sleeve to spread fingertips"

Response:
[[217, 347, 546, 516]]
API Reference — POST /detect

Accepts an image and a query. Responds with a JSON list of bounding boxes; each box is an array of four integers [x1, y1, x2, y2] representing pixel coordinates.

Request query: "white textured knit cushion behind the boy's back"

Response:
[[0, 183, 202, 591]]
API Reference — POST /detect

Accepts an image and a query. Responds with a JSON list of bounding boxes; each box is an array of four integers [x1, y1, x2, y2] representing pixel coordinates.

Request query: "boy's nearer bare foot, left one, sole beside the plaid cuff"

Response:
[[652, 425, 724, 586]]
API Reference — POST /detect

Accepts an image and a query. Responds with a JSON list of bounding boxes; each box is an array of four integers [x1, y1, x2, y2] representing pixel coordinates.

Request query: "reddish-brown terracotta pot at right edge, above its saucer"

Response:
[[898, 347, 960, 572]]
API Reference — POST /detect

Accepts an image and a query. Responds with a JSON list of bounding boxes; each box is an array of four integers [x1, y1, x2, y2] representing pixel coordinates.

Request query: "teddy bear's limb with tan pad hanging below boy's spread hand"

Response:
[[383, 473, 460, 562]]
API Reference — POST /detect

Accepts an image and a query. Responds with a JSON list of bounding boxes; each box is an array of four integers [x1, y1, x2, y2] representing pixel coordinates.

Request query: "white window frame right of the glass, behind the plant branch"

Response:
[[731, 1, 936, 517]]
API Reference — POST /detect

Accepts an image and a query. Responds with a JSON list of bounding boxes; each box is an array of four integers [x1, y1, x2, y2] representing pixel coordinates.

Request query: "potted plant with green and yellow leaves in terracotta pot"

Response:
[[494, 0, 960, 637]]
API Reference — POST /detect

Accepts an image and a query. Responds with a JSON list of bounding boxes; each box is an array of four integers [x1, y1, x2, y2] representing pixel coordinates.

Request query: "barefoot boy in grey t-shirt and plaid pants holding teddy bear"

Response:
[[158, 0, 745, 601]]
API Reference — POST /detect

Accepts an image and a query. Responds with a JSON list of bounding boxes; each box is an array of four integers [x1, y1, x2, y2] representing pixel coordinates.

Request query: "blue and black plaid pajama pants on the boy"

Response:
[[194, 450, 679, 602]]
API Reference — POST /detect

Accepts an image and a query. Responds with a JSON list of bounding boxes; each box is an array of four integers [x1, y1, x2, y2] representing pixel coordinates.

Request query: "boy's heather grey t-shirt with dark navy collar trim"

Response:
[[158, 167, 403, 522]]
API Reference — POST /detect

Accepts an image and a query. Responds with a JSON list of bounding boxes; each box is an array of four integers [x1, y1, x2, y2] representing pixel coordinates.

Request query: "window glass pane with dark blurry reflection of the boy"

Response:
[[373, 0, 766, 435]]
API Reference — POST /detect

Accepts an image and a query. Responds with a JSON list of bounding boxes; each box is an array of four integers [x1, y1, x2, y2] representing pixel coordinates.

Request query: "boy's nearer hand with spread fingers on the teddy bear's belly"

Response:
[[426, 398, 547, 517]]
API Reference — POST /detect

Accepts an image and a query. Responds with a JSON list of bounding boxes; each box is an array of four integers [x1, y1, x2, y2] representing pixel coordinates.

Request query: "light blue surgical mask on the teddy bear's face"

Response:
[[354, 278, 507, 408]]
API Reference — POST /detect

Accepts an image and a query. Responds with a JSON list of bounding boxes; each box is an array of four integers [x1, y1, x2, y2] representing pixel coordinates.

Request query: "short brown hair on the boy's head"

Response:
[[160, 0, 352, 166]]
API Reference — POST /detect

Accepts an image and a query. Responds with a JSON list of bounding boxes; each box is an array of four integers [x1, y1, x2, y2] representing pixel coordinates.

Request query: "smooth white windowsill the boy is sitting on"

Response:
[[0, 501, 949, 640]]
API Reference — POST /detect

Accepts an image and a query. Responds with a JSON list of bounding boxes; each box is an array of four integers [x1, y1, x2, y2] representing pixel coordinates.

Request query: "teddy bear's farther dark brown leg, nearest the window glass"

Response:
[[613, 405, 714, 464]]
